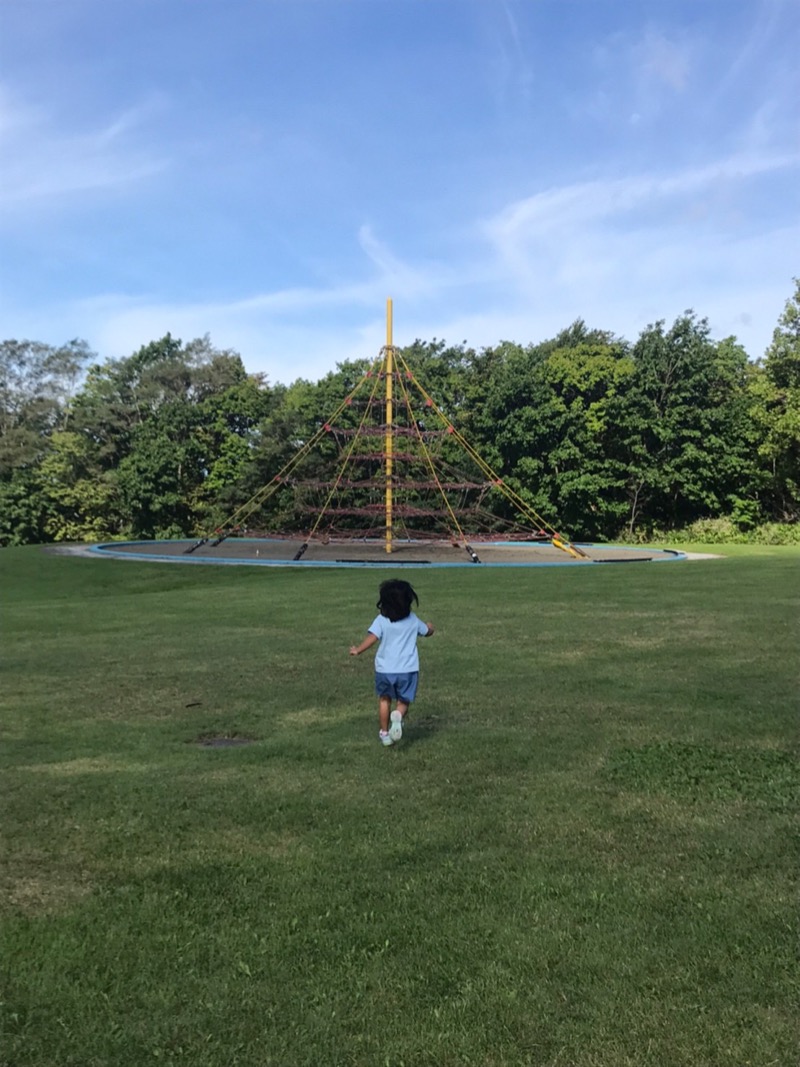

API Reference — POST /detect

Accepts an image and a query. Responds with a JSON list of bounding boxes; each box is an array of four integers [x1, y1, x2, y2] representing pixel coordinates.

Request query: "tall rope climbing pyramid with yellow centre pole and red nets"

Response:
[[187, 301, 583, 562]]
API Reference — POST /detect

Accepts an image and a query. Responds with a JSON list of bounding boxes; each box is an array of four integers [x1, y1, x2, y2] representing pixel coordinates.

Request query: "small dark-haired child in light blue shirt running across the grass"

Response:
[[350, 578, 433, 745]]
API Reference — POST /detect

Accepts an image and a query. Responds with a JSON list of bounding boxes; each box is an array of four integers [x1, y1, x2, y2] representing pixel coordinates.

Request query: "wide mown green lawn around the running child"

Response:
[[0, 546, 800, 1067]]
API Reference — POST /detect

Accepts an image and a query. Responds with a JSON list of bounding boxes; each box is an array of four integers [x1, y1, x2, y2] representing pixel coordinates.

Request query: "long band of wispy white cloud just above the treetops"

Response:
[[25, 158, 800, 382]]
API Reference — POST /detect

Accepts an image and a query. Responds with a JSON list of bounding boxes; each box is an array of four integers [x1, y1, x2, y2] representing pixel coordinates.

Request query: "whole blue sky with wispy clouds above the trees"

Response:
[[0, 0, 800, 383]]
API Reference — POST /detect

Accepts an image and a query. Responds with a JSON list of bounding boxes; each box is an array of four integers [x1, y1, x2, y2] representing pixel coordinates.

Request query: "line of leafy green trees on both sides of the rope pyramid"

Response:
[[0, 282, 800, 545]]
